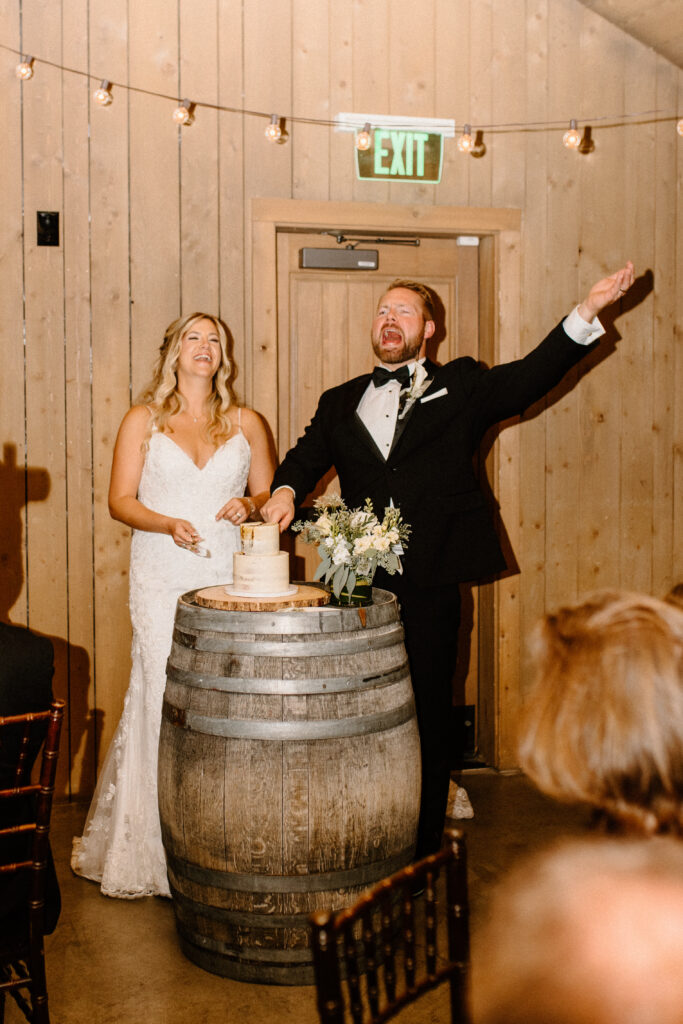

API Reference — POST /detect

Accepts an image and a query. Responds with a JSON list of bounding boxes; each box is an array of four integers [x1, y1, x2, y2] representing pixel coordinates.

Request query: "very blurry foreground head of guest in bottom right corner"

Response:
[[472, 837, 683, 1024]]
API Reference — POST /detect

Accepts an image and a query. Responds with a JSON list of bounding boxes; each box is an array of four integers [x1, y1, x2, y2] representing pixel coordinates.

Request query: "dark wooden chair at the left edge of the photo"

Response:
[[0, 700, 65, 1024]]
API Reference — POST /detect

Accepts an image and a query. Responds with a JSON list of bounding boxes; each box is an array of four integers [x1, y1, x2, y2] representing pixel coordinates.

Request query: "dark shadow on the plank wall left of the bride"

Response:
[[0, 443, 101, 796]]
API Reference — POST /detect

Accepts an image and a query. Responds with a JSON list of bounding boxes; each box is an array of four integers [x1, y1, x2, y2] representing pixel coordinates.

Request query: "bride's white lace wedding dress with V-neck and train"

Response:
[[72, 423, 251, 899]]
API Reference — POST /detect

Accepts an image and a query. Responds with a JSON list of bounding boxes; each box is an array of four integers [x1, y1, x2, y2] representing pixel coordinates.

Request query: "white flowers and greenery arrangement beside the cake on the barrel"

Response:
[[292, 495, 411, 598]]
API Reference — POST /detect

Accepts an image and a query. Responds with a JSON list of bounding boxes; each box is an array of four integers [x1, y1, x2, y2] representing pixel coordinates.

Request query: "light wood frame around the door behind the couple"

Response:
[[250, 199, 521, 769]]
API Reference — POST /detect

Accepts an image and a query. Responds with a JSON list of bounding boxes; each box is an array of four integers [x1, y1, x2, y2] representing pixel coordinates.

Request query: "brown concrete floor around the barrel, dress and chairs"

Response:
[[5, 770, 586, 1024]]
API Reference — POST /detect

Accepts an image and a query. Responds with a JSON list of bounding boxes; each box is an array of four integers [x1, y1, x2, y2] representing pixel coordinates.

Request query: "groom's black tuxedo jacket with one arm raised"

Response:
[[272, 324, 593, 586]]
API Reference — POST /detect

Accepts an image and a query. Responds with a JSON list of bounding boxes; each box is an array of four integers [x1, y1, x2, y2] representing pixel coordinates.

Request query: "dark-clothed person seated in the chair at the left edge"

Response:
[[0, 623, 61, 939]]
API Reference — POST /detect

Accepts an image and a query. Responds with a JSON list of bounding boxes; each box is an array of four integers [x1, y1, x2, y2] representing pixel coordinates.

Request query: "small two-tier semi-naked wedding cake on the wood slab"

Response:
[[225, 522, 297, 597]]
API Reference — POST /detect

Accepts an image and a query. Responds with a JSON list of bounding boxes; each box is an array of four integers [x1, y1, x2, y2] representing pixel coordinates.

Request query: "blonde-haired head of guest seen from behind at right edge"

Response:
[[519, 591, 683, 836]]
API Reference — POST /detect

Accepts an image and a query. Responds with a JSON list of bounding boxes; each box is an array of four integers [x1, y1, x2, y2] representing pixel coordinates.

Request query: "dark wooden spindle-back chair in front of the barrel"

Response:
[[310, 829, 469, 1024]]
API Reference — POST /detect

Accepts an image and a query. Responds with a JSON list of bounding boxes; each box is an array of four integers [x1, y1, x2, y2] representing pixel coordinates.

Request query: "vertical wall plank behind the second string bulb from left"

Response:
[[90, 0, 134, 759]]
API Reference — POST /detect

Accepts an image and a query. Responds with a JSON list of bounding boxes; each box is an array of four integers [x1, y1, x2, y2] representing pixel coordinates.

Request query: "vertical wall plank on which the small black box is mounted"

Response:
[[23, 0, 67, 638]]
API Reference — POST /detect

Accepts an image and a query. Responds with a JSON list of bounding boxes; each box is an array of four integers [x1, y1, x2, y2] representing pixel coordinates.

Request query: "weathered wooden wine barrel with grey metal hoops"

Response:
[[159, 589, 420, 985]]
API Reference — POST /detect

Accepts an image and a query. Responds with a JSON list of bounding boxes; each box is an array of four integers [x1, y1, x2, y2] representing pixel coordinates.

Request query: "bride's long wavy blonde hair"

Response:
[[138, 312, 237, 445]]
